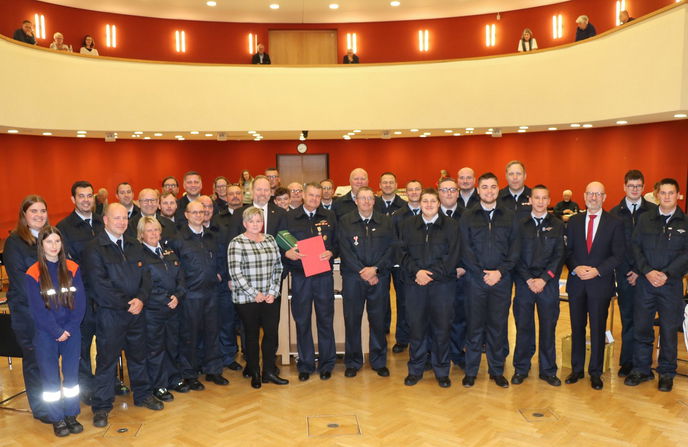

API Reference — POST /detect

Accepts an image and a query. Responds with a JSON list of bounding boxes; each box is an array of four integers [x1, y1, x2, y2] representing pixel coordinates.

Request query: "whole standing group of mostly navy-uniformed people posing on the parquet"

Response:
[[4, 160, 688, 436]]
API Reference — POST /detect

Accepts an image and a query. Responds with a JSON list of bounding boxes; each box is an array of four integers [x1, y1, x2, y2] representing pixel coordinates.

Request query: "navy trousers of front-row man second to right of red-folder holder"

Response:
[[404, 281, 456, 377]]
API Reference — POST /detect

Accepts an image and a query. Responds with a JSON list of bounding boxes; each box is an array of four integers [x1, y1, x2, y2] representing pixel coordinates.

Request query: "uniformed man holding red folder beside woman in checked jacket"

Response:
[[284, 183, 337, 382]]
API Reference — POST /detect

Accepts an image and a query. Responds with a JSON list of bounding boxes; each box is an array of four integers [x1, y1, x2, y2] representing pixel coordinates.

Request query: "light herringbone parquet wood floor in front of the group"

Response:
[[0, 303, 688, 447]]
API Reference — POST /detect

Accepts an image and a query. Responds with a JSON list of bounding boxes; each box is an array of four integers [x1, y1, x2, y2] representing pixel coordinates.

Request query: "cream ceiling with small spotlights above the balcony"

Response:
[[44, 0, 564, 23]]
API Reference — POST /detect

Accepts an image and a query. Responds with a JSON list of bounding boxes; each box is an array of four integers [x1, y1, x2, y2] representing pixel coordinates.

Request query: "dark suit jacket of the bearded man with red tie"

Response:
[[566, 211, 626, 298]]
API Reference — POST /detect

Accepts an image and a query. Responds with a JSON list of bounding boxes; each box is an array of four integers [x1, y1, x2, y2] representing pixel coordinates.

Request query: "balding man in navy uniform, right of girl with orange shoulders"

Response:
[[84, 203, 163, 427]]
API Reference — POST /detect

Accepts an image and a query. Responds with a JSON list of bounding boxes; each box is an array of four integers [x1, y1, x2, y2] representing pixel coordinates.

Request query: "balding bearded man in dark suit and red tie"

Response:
[[566, 182, 625, 390]]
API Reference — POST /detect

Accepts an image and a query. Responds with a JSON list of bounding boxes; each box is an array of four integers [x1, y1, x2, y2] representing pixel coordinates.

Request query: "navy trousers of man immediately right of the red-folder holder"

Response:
[[342, 274, 389, 369]]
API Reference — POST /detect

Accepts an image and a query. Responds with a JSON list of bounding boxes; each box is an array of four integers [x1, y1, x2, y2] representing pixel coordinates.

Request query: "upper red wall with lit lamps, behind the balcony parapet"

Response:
[[0, 0, 674, 64]]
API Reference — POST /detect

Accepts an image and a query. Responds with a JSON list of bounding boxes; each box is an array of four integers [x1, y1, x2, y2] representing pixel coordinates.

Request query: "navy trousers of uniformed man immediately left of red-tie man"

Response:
[[513, 278, 559, 376]]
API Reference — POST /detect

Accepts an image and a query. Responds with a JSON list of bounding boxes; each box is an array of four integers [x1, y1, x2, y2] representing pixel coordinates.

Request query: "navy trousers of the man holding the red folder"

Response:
[[291, 272, 337, 374]]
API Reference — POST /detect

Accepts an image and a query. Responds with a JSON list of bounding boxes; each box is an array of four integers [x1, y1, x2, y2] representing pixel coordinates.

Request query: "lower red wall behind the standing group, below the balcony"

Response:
[[0, 120, 688, 235]]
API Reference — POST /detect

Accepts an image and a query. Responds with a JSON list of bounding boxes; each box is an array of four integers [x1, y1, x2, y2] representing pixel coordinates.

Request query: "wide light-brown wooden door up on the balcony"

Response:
[[269, 30, 337, 65]]
